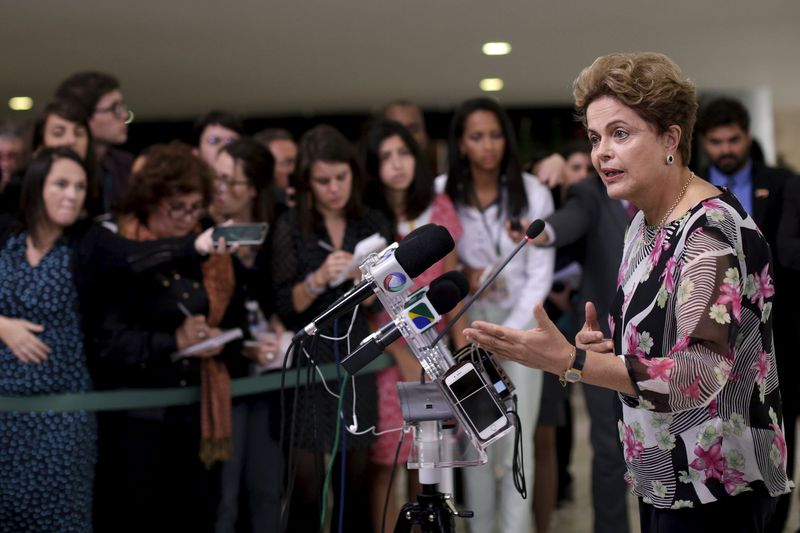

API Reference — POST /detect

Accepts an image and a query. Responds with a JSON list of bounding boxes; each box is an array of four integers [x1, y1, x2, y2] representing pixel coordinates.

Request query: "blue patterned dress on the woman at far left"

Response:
[[0, 233, 97, 533]]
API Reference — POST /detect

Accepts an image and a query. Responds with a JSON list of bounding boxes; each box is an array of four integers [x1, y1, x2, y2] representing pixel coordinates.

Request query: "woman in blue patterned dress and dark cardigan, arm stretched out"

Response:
[[0, 147, 222, 532]]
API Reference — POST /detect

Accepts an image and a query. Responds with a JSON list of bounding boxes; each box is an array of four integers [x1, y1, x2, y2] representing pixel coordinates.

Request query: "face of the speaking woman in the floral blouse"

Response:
[[586, 96, 669, 203]]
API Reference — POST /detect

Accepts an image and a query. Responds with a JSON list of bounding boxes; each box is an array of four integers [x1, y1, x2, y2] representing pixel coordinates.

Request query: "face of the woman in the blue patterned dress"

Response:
[[42, 157, 86, 228]]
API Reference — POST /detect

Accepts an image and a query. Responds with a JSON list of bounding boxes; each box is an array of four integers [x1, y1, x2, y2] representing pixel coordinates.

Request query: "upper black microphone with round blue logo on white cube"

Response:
[[295, 224, 455, 340]]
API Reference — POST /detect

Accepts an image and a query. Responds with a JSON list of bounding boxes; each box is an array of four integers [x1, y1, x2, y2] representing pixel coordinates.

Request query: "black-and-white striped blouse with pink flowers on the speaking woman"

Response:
[[609, 187, 793, 509]]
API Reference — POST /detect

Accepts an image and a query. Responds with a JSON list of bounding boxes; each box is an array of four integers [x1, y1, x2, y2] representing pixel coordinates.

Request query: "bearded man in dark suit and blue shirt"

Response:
[[697, 98, 800, 532]]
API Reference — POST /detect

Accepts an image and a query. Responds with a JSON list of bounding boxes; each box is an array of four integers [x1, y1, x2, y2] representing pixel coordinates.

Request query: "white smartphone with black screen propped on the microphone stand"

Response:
[[444, 361, 509, 440]]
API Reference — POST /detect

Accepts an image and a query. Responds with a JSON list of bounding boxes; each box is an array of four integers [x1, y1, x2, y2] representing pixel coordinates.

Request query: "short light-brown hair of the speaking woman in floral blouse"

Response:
[[572, 52, 697, 165]]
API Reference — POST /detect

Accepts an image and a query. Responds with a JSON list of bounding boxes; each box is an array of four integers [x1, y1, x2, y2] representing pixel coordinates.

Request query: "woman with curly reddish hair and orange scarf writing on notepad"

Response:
[[89, 142, 247, 531]]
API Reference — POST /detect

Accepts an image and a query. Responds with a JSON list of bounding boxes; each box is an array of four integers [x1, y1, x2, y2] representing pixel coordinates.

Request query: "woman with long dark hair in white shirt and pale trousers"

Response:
[[436, 98, 555, 533]]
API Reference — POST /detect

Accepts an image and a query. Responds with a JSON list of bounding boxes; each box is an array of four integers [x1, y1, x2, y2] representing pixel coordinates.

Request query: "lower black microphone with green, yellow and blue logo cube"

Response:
[[342, 271, 469, 375]]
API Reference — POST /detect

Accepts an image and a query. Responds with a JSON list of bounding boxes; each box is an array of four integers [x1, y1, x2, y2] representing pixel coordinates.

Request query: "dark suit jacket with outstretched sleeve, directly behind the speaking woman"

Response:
[[547, 175, 628, 336]]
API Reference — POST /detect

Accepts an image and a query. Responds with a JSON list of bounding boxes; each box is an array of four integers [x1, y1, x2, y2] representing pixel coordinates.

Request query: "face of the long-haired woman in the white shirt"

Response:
[[459, 109, 506, 172]]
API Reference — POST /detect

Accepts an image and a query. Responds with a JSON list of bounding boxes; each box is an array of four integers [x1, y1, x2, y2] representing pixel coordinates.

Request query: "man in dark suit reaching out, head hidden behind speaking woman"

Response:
[[534, 174, 628, 533]]
